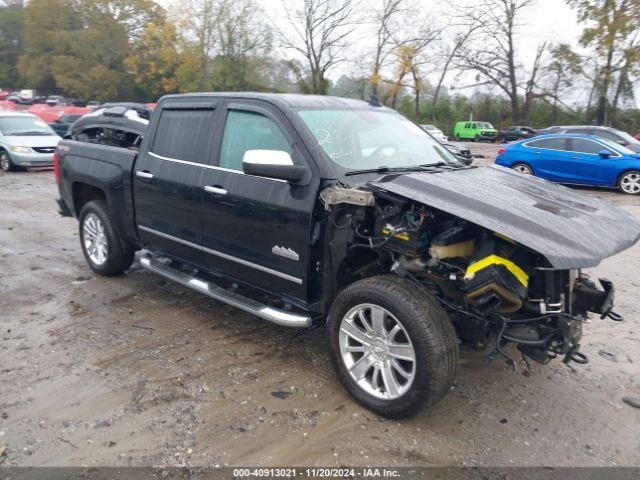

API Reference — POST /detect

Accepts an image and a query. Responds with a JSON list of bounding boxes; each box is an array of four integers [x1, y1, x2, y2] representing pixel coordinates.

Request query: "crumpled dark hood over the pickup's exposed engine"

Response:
[[369, 165, 640, 269]]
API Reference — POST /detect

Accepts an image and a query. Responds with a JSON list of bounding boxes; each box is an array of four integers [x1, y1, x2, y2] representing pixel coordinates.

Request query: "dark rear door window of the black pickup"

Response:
[[150, 108, 215, 163]]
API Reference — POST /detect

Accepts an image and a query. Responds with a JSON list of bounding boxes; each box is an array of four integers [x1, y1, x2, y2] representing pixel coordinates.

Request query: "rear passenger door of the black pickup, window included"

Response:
[[133, 99, 218, 263]]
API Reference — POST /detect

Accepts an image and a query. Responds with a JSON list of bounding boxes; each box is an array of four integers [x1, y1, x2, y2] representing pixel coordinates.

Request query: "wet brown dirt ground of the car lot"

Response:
[[0, 152, 640, 466]]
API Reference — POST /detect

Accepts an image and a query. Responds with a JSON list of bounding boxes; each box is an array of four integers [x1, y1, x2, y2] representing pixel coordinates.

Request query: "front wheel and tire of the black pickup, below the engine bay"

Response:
[[328, 276, 458, 418]]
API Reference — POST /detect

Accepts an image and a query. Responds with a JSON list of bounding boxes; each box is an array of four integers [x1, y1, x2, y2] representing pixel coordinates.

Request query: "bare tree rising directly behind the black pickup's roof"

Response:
[[282, 0, 358, 95]]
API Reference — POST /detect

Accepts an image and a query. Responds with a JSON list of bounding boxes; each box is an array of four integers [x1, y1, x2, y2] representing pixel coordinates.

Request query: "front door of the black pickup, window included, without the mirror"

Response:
[[202, 100, 319, 303]]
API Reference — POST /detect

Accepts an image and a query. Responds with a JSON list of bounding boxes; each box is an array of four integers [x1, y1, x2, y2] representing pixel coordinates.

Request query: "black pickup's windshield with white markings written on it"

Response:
[[298, 109, 460, 170]]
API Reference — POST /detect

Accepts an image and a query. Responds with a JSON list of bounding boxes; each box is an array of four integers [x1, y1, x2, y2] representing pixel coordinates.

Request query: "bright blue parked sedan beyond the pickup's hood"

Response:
[[496, 134, 640, 195]]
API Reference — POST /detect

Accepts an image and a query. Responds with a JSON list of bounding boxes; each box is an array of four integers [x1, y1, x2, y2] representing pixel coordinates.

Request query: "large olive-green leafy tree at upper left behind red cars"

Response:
[[18, 0, 163, 101]]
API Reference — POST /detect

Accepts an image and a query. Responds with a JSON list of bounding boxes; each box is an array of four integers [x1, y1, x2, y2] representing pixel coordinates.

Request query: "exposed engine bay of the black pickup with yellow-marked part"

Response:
[[321, 187, 622, 369]]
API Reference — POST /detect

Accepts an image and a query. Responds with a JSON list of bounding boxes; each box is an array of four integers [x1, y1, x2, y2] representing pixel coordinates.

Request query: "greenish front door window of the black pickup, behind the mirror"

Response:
[[219, 110, 292, 171]]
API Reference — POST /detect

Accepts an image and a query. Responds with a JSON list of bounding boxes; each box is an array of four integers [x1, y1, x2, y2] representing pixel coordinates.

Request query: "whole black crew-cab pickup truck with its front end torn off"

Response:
[[55, 94, 640, 417]]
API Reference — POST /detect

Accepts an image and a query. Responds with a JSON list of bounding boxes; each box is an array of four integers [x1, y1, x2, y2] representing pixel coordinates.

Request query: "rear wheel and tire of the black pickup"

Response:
[[80, 200, 135, 276]]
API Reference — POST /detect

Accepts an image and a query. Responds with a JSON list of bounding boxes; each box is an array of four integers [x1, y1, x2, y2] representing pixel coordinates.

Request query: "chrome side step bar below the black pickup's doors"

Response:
[[140, 255, 311, 327]]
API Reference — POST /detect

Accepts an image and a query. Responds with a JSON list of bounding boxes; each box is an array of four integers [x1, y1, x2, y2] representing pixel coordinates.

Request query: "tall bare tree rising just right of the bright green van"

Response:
[[458, 0, 535, 122]]
